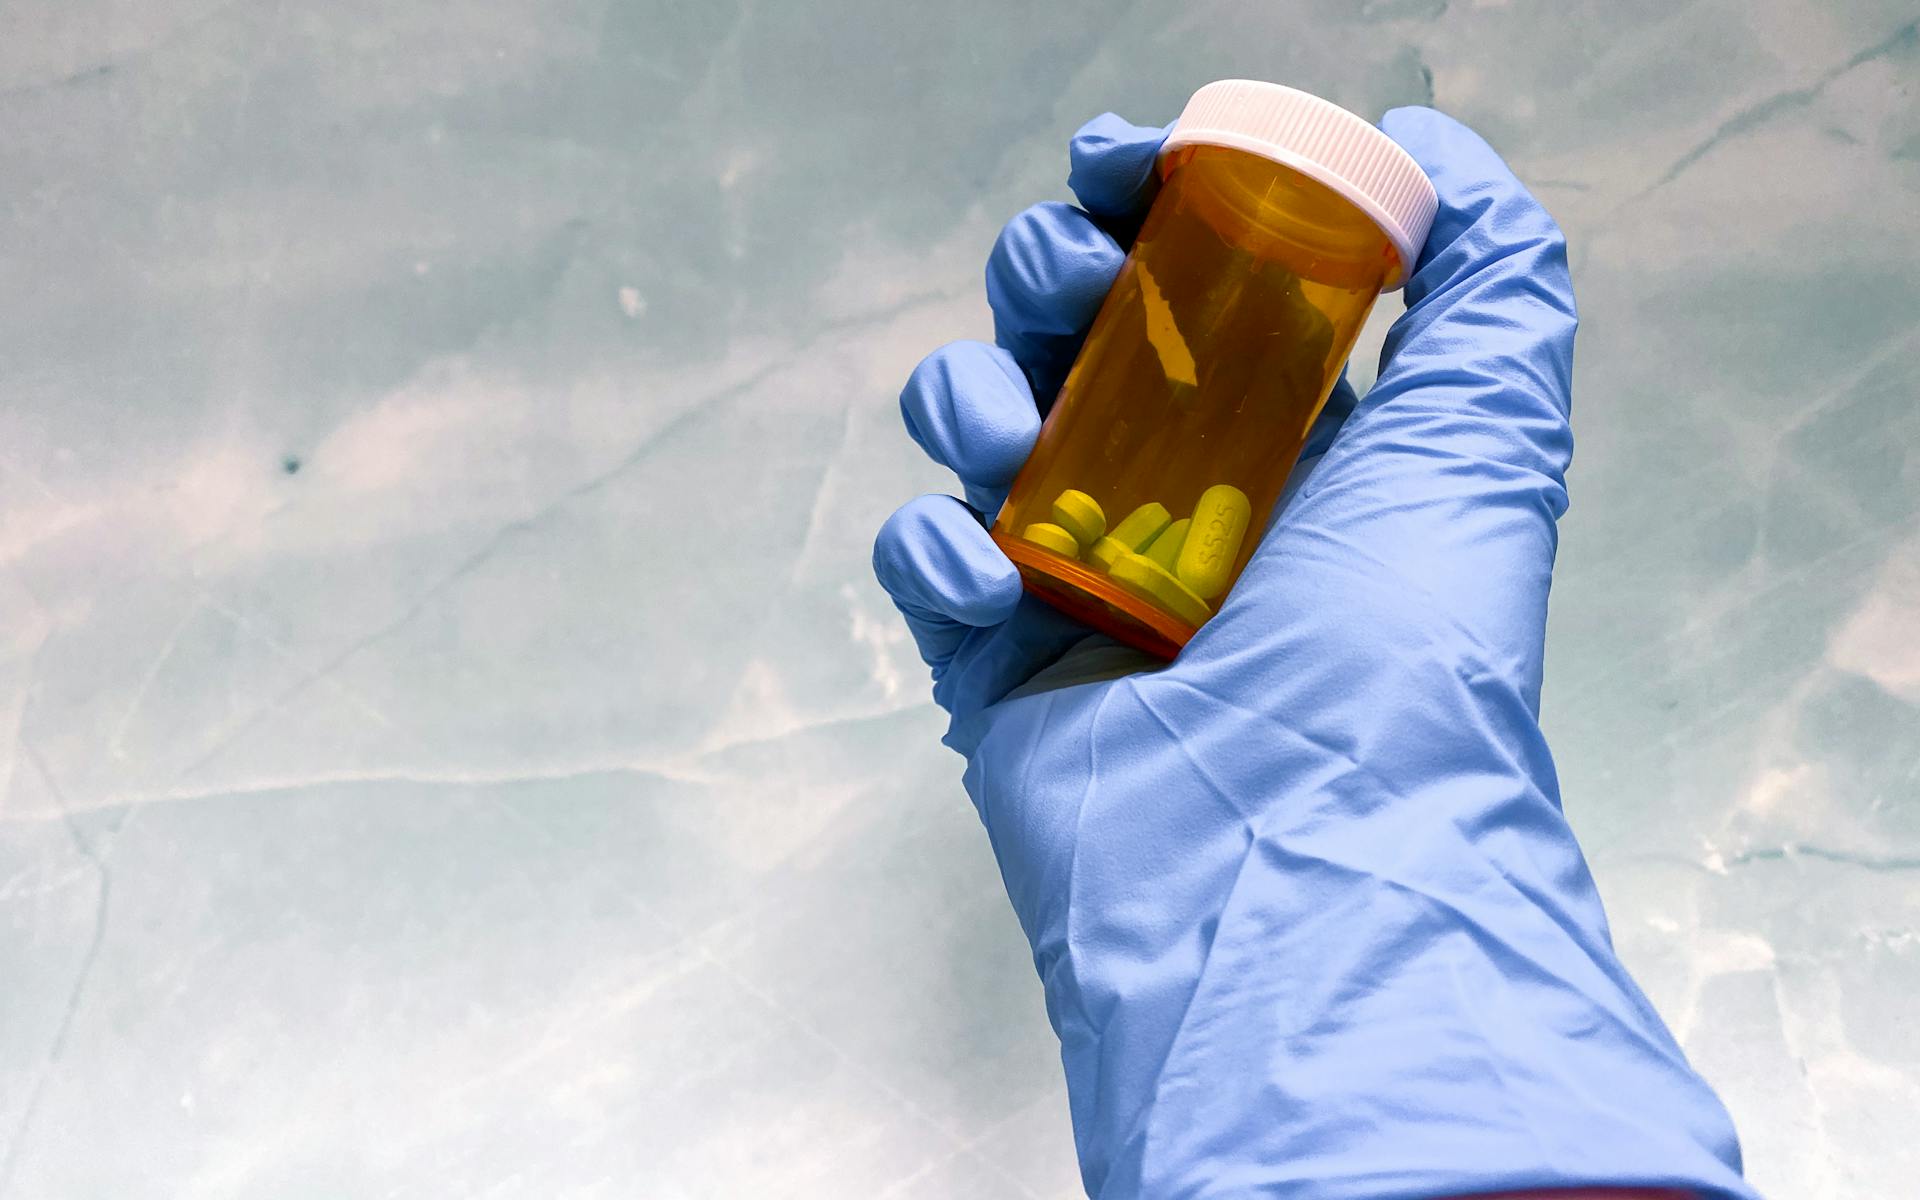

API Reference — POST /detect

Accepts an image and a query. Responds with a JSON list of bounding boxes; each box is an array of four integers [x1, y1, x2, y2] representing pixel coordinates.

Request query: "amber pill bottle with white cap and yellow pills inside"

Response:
[[993, 79, 1436, 659]]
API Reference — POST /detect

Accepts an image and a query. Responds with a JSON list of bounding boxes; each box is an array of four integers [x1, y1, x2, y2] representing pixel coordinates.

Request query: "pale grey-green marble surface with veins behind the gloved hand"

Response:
[[0, 0, 1920, 1200]]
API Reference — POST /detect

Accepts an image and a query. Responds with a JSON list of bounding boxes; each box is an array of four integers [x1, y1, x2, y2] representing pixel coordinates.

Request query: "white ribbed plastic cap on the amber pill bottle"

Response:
[[1162, 79, 1440, 288]]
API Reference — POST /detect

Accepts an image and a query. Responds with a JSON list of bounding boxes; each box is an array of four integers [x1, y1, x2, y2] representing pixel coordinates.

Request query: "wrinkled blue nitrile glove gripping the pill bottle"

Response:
[[874, 109, 1753, 1200]]
